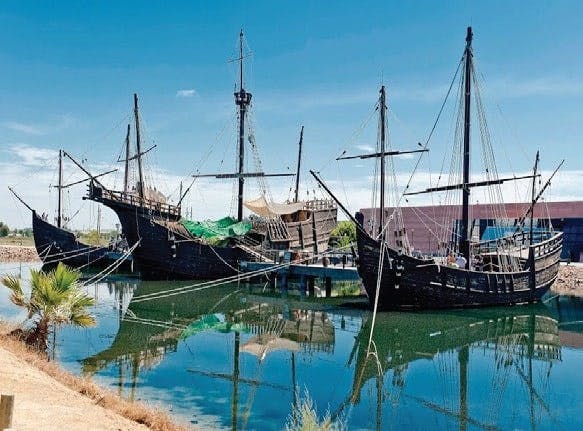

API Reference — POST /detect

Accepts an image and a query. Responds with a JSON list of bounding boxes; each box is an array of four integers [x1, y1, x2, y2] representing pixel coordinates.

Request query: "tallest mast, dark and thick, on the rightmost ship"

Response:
[[459, 27, 473, 265]]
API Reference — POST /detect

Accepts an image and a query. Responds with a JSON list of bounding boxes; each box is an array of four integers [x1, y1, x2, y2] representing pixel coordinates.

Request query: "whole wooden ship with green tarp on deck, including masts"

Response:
[[87, 32, 337, 279]]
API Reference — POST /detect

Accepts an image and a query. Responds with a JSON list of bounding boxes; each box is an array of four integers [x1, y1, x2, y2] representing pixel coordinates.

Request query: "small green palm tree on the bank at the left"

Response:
[[2, 263, 95, 352]]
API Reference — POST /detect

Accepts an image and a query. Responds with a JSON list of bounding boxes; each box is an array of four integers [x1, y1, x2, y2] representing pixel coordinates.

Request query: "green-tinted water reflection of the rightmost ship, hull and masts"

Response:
[[342, 305, 561, 430]]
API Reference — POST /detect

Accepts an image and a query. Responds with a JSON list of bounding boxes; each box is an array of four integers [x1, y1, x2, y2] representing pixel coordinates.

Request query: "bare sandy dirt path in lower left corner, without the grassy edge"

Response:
[[0, 347, 149, 431]]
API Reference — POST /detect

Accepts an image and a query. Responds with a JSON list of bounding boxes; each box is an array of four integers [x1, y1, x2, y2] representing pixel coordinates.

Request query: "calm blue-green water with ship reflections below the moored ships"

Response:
[[0, 264, 583, 430]]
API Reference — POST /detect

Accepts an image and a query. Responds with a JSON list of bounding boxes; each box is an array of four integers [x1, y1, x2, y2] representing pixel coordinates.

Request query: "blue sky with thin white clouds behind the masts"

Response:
[[0, 1, 583, 227]]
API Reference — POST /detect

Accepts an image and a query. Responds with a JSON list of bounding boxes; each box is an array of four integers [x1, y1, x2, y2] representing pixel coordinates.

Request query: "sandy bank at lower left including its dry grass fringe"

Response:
[[0, 328, 186, 431]]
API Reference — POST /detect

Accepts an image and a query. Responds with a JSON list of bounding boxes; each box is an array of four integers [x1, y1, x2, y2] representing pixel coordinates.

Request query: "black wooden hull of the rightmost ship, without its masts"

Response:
[[357, 213, 562, 310]]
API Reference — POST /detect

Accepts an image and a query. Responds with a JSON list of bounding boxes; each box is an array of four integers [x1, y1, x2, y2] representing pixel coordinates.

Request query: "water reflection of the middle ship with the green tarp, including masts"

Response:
[[82, 281, 334, 429]]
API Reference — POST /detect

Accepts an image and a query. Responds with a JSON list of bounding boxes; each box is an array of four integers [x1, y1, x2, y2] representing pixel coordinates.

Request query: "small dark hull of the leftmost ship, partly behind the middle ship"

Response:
[[32, 211, 109, 268]]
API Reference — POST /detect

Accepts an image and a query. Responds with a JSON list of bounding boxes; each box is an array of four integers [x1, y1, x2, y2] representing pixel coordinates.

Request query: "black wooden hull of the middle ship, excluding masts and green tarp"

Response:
[[88, 184, 336, 280]]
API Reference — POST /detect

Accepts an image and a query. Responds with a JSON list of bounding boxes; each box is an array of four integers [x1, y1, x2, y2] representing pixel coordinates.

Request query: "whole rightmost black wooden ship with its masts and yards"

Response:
[[312, 27, 563, 310]]
